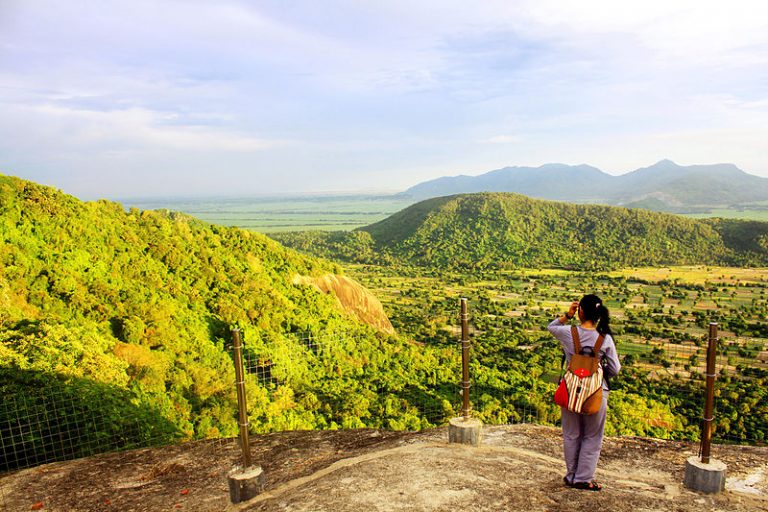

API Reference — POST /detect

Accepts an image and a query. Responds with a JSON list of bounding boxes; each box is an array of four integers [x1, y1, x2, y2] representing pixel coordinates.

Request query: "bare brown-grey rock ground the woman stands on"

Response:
[[0, 425, 768, 512]]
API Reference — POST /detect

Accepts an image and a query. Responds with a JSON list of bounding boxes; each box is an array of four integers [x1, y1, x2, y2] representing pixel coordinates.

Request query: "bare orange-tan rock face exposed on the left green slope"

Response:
[[293, 274, 395, 334]]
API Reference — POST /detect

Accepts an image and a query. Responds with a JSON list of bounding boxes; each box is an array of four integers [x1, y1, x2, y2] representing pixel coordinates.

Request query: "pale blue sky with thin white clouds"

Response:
[[0, 0, 768, 199]]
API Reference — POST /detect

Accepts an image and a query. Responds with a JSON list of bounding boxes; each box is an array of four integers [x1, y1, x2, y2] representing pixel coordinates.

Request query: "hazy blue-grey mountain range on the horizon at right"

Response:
[[403, 160, 768, 212]]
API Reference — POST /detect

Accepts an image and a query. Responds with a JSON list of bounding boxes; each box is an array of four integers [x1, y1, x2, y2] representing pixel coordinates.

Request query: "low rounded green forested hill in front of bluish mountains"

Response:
[[277, 193, 768, 269]]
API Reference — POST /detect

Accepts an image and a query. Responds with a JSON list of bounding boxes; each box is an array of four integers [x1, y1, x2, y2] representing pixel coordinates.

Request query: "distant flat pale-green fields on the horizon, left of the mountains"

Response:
[[123, 195, 413, 233]]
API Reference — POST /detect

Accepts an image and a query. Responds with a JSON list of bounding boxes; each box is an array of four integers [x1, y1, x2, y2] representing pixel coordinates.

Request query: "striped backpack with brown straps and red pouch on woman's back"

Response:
[[555, 326, 605, 414]]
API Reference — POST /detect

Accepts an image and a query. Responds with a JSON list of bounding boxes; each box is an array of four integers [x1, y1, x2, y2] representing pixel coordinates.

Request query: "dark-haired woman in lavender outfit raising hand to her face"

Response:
[[548, 295, 621, 491]]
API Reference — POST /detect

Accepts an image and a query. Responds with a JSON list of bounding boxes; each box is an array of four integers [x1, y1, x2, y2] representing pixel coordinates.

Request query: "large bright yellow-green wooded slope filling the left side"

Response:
[[0, 176, 452, 471]]
